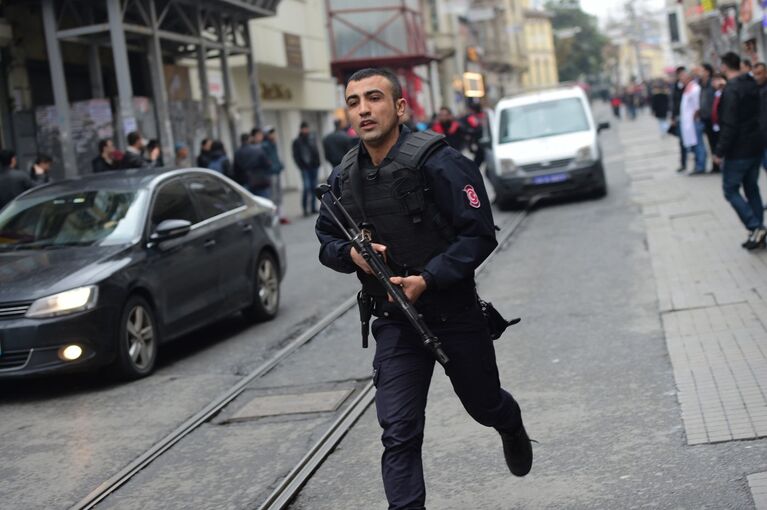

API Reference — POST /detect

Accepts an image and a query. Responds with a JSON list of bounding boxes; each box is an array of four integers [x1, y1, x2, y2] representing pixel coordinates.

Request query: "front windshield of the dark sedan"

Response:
[[0, 190, 145, 250]]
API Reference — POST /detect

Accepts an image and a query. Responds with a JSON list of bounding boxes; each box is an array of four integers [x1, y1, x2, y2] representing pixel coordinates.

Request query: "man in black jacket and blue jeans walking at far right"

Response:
[[714, 52, 767, 250]]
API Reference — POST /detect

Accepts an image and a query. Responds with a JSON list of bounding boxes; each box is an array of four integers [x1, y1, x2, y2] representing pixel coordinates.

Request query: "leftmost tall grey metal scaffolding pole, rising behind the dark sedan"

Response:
[[42, 0, 78, 177]]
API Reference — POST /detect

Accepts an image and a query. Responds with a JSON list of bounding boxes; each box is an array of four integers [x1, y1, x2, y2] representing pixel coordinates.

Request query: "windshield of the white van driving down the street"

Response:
[[498, 97, 589, 143]]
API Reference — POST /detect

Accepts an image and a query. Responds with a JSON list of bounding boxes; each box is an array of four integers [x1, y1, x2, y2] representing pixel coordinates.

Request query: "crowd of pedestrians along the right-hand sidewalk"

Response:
[[610, 52, 767, 250]]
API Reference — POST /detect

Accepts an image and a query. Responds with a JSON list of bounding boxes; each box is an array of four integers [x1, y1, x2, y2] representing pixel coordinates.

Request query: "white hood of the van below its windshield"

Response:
[[495, 131, 594, 165]]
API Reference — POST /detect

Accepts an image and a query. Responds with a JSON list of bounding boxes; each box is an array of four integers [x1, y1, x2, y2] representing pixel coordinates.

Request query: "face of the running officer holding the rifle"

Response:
[[346, 76, 407, 144]]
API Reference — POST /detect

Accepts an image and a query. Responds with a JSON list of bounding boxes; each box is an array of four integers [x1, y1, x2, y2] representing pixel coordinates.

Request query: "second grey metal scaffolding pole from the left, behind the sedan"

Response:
[[106, 0, 138, 148]]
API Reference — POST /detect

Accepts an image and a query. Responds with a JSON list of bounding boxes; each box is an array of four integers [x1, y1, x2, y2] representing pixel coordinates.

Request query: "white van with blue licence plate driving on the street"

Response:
[[487, 86, 610, 208]]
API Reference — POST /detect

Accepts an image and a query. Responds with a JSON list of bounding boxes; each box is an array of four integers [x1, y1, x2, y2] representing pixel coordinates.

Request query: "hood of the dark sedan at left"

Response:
[[0, 245, 132, 303]]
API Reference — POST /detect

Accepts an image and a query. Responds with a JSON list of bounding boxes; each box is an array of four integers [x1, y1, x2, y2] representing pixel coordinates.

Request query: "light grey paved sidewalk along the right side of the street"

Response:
[[618, 117, 767, 508]]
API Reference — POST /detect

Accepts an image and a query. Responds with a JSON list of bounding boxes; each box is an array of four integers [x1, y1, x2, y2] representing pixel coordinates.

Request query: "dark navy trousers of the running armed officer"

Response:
[[372, 304, 522, 510]]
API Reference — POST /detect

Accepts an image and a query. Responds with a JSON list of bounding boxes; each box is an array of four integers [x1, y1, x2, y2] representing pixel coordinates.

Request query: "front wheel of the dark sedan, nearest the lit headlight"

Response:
[[115, 294, 160, 380]]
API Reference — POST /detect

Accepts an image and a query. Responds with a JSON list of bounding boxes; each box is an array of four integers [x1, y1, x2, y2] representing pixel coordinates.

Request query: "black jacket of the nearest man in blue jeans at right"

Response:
[[714, 74, 762, 159]]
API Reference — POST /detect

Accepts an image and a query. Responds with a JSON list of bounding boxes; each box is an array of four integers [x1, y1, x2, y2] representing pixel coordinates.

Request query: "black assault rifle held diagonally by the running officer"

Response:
[[315, 184, 450, 366]]
